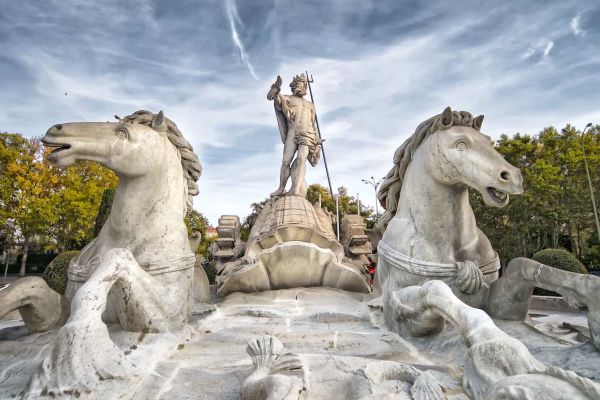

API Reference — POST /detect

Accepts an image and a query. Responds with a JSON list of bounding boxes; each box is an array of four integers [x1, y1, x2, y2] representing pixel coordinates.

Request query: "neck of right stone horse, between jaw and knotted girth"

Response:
[[396, 152, 479, 262]]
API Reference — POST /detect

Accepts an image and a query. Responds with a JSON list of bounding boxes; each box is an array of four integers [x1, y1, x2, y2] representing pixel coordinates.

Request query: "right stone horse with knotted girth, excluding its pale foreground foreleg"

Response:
[[376, 107, 600, 349]]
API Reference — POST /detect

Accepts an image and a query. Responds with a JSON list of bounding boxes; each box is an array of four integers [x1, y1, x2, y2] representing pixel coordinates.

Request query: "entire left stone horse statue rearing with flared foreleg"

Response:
[[0, 111, 201, 394]]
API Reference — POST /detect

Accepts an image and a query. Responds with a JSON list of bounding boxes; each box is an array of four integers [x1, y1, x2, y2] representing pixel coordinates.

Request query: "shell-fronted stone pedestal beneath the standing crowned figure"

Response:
[[217, 196, 370, 296]]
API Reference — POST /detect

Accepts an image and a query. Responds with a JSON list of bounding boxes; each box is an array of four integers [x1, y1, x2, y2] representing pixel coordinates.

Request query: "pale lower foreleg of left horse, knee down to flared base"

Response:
[[27, 249, 141, 395]]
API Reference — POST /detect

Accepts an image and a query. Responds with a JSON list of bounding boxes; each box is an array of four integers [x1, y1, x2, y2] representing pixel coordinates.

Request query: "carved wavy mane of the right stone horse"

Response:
[[375, 107, 483, 235]]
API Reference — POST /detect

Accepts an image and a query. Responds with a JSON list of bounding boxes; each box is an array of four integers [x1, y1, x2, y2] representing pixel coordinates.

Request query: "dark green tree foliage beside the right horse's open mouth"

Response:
[[470, 125, 600, 267]]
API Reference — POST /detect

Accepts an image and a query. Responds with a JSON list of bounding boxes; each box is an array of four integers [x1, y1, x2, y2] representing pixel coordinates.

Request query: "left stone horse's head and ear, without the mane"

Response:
[[42, 111, 172, 177]]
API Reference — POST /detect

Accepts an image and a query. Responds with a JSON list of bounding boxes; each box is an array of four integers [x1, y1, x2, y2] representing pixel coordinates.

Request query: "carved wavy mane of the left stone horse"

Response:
[[121, 110, 202, 214]]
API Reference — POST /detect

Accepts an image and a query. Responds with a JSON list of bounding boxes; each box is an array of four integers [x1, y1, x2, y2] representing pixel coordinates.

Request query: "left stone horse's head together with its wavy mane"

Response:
[[42, 110, 202, 214]]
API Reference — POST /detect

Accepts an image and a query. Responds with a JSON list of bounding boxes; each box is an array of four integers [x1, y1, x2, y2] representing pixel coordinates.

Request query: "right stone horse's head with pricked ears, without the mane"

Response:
[[423, 107, 523, 207]]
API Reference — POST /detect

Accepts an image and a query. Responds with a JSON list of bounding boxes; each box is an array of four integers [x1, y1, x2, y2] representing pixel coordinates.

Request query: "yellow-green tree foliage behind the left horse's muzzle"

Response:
[[0, 133, 117, 271]]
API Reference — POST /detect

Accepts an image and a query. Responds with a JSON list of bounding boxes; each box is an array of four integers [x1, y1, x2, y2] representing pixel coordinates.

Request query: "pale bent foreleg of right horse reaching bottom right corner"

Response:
[[388, 280, 600, 400]]
